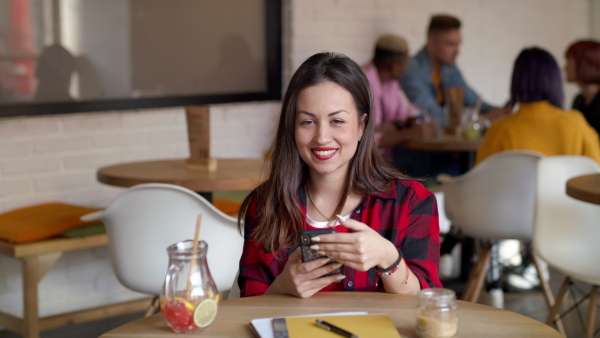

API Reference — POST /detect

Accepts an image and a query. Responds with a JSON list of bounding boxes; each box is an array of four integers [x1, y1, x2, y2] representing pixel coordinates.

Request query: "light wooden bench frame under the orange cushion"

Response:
[[0, 234, 150, 338]]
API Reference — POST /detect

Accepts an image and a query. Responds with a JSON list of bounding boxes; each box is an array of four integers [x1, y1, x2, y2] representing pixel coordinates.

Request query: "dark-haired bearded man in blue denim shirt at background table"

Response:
[[399, 15, 509, 126]]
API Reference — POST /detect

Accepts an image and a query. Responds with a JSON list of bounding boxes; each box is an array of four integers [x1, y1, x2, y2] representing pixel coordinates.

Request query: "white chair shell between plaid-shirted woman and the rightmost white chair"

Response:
[[438, 150, 543, 239]]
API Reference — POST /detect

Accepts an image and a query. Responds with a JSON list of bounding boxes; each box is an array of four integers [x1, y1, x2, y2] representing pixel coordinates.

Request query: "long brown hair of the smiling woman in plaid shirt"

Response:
[[238, 53, 408, 252]]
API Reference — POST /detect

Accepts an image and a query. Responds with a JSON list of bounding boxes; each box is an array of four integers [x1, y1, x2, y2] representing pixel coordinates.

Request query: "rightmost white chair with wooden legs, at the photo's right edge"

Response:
[[533, 156, 600, 337]]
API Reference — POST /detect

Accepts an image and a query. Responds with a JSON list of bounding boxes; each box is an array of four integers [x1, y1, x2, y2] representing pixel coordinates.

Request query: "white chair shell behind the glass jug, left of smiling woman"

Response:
[[101, 184, 244, 295]]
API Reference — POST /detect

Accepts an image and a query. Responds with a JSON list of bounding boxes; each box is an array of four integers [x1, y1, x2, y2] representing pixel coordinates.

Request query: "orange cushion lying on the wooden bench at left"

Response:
[[0, 203, 101, 243]]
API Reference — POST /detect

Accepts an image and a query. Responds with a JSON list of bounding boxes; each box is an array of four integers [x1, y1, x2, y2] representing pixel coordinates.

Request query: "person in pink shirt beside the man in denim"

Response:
[[362, 34, 435, 162]]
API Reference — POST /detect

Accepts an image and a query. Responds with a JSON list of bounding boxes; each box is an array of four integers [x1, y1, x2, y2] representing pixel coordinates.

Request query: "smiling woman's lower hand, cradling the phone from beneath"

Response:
[[265, 247, 344, 298]]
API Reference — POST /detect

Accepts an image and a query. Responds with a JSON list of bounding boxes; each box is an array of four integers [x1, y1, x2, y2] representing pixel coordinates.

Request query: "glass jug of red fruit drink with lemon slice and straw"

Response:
[[160, 240, 218, 333]]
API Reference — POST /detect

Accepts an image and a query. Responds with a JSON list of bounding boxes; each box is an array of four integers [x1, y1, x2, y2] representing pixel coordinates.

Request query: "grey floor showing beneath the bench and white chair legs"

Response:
[[0, 270, 600, 338]]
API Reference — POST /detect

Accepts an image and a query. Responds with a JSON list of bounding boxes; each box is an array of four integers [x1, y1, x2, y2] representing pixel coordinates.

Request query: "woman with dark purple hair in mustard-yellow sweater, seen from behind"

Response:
[[476, 47, 600, 163]]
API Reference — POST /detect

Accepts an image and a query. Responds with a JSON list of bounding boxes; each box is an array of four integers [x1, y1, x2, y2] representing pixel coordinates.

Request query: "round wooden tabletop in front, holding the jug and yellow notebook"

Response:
[[101, 292, 561, 338]]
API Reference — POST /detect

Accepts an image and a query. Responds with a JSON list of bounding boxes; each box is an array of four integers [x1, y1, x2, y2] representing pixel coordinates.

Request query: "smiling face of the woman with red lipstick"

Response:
[[295, 82, 365, 179]]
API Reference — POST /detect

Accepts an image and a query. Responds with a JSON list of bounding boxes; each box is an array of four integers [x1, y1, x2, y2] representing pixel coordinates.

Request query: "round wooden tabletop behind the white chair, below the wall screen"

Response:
[[96, 159, 264, 198]]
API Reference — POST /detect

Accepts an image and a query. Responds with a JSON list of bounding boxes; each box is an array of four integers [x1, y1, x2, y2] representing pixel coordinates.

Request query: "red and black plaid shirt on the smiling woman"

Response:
[[238, 180, 442, 297]]
